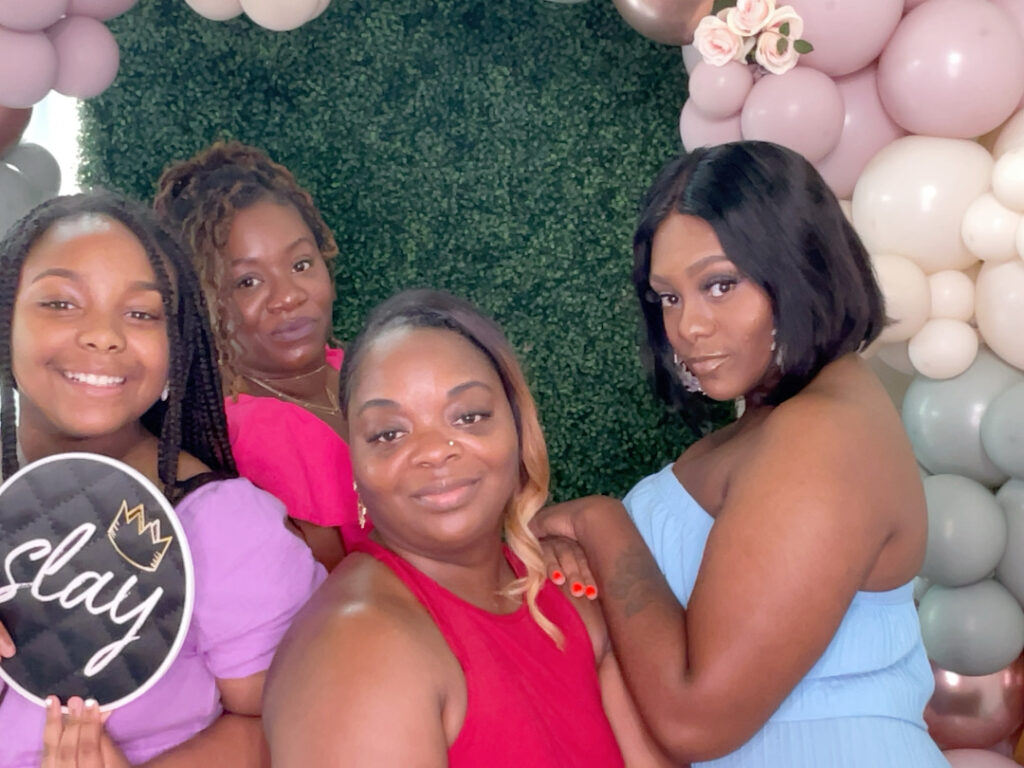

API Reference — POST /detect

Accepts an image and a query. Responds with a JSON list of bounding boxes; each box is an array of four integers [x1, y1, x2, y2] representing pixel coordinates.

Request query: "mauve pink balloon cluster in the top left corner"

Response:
[[0, 0, 138, 108]]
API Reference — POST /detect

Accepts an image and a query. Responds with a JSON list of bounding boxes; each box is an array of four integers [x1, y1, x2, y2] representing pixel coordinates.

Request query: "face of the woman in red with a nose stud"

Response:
[[348, 328, 519, 558]]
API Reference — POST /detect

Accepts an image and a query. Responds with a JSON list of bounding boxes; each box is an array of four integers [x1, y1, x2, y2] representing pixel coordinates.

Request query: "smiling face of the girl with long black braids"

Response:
[[11, 214, 168, 450]]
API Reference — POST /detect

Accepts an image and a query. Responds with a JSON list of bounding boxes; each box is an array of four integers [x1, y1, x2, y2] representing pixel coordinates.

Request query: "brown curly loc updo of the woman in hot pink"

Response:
[[153, 141, 338, 395]]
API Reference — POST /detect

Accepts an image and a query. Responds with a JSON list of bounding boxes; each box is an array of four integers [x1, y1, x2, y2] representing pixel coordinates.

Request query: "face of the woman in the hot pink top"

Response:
[[221, 200, 334, 377]]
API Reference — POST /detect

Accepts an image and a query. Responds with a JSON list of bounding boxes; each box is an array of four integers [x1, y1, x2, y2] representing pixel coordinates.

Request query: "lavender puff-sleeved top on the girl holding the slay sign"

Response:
[[0, 478, 326, 768]]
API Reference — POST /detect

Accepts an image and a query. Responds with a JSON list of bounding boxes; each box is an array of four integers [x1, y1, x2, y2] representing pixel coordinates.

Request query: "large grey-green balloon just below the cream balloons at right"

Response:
[[902, 349, 1024, 487]]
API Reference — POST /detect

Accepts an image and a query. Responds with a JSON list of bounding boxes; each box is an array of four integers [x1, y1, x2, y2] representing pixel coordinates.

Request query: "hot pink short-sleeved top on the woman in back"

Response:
[[224, 347, 361, 551]]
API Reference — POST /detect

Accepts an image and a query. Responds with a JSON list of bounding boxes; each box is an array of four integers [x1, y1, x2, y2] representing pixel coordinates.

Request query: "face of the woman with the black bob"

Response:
[[649, 212, 773, 400]]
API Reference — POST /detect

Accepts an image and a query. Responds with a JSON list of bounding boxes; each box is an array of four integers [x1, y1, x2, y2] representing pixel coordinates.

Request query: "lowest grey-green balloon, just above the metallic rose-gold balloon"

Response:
[[918, 579, 1024, 675]]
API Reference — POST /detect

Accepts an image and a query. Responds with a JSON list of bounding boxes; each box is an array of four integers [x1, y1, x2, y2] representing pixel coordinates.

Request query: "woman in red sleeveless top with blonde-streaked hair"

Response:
[[264, 290, 668, 768]]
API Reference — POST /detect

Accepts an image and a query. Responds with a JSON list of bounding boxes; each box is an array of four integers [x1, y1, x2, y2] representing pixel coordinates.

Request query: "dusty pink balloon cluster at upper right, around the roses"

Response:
[[679, 0, 1024, 199]]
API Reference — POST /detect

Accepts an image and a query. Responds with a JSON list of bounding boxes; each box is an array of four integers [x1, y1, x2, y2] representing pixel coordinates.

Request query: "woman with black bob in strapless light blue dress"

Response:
[[531, 141, 947, 768]]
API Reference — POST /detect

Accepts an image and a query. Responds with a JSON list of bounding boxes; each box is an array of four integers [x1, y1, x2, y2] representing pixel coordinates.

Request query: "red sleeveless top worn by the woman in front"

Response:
[[352, 540, 624, 768]]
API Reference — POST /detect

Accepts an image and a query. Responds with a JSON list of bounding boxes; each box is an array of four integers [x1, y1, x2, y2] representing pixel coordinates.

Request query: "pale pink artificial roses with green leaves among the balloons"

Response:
[[693, 0, 814, 75]]
